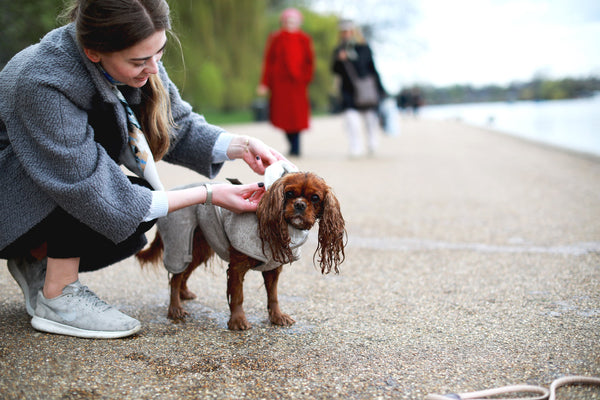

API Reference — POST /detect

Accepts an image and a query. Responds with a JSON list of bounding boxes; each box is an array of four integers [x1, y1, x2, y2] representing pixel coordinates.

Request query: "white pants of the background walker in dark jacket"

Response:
[[344, 108, 379, 156]]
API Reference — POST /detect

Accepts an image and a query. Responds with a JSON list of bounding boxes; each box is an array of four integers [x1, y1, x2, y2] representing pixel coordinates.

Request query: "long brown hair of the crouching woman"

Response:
[[63, 0, 174, 161]]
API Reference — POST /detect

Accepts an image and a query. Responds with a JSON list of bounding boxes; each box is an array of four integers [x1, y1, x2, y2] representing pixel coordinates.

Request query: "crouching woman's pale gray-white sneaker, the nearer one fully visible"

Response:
[[31, 281, 142, 339]]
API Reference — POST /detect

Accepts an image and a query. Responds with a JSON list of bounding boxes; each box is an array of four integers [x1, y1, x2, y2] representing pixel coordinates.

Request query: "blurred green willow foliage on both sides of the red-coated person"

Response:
[[165, 0, 337, 111]]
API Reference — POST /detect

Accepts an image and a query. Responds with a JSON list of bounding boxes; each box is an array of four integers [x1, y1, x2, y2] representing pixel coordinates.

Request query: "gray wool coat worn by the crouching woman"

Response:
[[0, 24, 223, 250]]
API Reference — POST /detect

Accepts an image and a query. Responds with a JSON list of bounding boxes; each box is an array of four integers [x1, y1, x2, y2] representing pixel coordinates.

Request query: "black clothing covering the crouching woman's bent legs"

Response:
[[0, 178, 156, 272]]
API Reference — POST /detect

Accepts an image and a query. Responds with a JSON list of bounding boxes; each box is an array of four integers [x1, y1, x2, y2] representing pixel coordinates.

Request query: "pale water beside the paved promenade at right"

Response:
[[421, 94, 600, 156]]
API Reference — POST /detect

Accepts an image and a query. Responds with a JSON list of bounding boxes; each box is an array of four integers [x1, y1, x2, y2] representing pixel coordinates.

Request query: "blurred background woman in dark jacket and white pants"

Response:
[[332, 20, 385, 157]]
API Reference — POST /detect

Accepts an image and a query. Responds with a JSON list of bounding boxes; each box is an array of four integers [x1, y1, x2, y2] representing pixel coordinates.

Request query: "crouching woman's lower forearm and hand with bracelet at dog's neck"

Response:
[[167, 182, 265, 213]]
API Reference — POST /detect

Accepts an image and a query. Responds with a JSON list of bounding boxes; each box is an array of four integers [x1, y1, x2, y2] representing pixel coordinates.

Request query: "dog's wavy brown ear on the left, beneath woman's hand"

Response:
[[256, 179, 293, 264]]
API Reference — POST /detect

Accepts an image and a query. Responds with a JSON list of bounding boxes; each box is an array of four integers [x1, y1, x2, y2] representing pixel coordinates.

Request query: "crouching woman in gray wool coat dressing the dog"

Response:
[[0, 0, 283, 338]]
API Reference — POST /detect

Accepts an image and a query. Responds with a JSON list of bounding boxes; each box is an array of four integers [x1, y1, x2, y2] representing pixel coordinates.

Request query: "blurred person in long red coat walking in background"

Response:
[[257, 8, 314, 156]]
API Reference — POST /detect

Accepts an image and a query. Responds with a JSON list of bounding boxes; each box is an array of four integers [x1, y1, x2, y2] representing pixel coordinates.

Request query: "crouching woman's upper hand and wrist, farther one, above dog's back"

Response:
[[227, 136, 293, 175]]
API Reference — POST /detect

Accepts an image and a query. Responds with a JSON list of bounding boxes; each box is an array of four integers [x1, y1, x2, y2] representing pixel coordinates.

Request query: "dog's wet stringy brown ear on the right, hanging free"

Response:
[[313, 188, 347, 274]]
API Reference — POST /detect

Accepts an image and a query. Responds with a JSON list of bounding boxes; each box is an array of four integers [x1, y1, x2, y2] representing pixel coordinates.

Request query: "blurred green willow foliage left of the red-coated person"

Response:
[[165, 0, 266, 110]]
